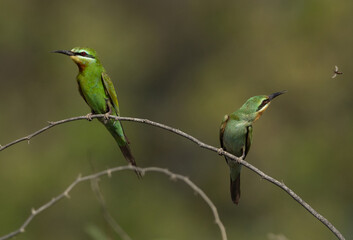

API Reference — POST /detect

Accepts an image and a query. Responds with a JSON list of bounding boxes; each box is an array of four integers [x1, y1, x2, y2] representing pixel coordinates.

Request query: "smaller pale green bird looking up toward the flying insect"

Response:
[[219, 91, 286, 204]]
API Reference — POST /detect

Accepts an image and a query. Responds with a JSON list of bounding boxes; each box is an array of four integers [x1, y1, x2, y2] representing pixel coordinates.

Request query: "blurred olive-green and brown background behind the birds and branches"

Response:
[[0, 0, 353, 240]]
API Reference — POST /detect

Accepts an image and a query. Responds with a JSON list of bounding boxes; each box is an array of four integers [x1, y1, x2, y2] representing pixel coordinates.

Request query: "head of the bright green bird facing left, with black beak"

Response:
[[54, 47, 99, 71]]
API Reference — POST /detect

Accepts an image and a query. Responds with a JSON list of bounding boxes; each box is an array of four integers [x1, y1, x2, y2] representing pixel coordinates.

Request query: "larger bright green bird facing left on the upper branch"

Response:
[[54, 47, 136, 172]]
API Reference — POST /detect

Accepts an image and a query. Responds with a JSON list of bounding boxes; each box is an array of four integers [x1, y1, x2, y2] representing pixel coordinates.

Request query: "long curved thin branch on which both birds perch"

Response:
[[0, 114, 345, 240]]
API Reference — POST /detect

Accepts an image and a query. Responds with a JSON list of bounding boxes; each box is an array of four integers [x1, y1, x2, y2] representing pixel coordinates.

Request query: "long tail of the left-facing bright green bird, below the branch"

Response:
[[101, 120, 142, 178]]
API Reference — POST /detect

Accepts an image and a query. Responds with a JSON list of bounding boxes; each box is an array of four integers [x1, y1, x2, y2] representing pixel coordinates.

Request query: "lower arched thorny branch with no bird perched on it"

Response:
[[0, 165, 227, 240]]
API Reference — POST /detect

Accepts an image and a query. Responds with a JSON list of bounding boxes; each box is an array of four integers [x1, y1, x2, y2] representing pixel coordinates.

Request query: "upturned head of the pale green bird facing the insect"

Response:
[[239, 90, 287, 122]]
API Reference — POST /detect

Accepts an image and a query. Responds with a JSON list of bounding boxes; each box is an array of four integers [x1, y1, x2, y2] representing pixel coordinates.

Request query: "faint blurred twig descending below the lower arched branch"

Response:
[[91, 178, 131, 240]]
